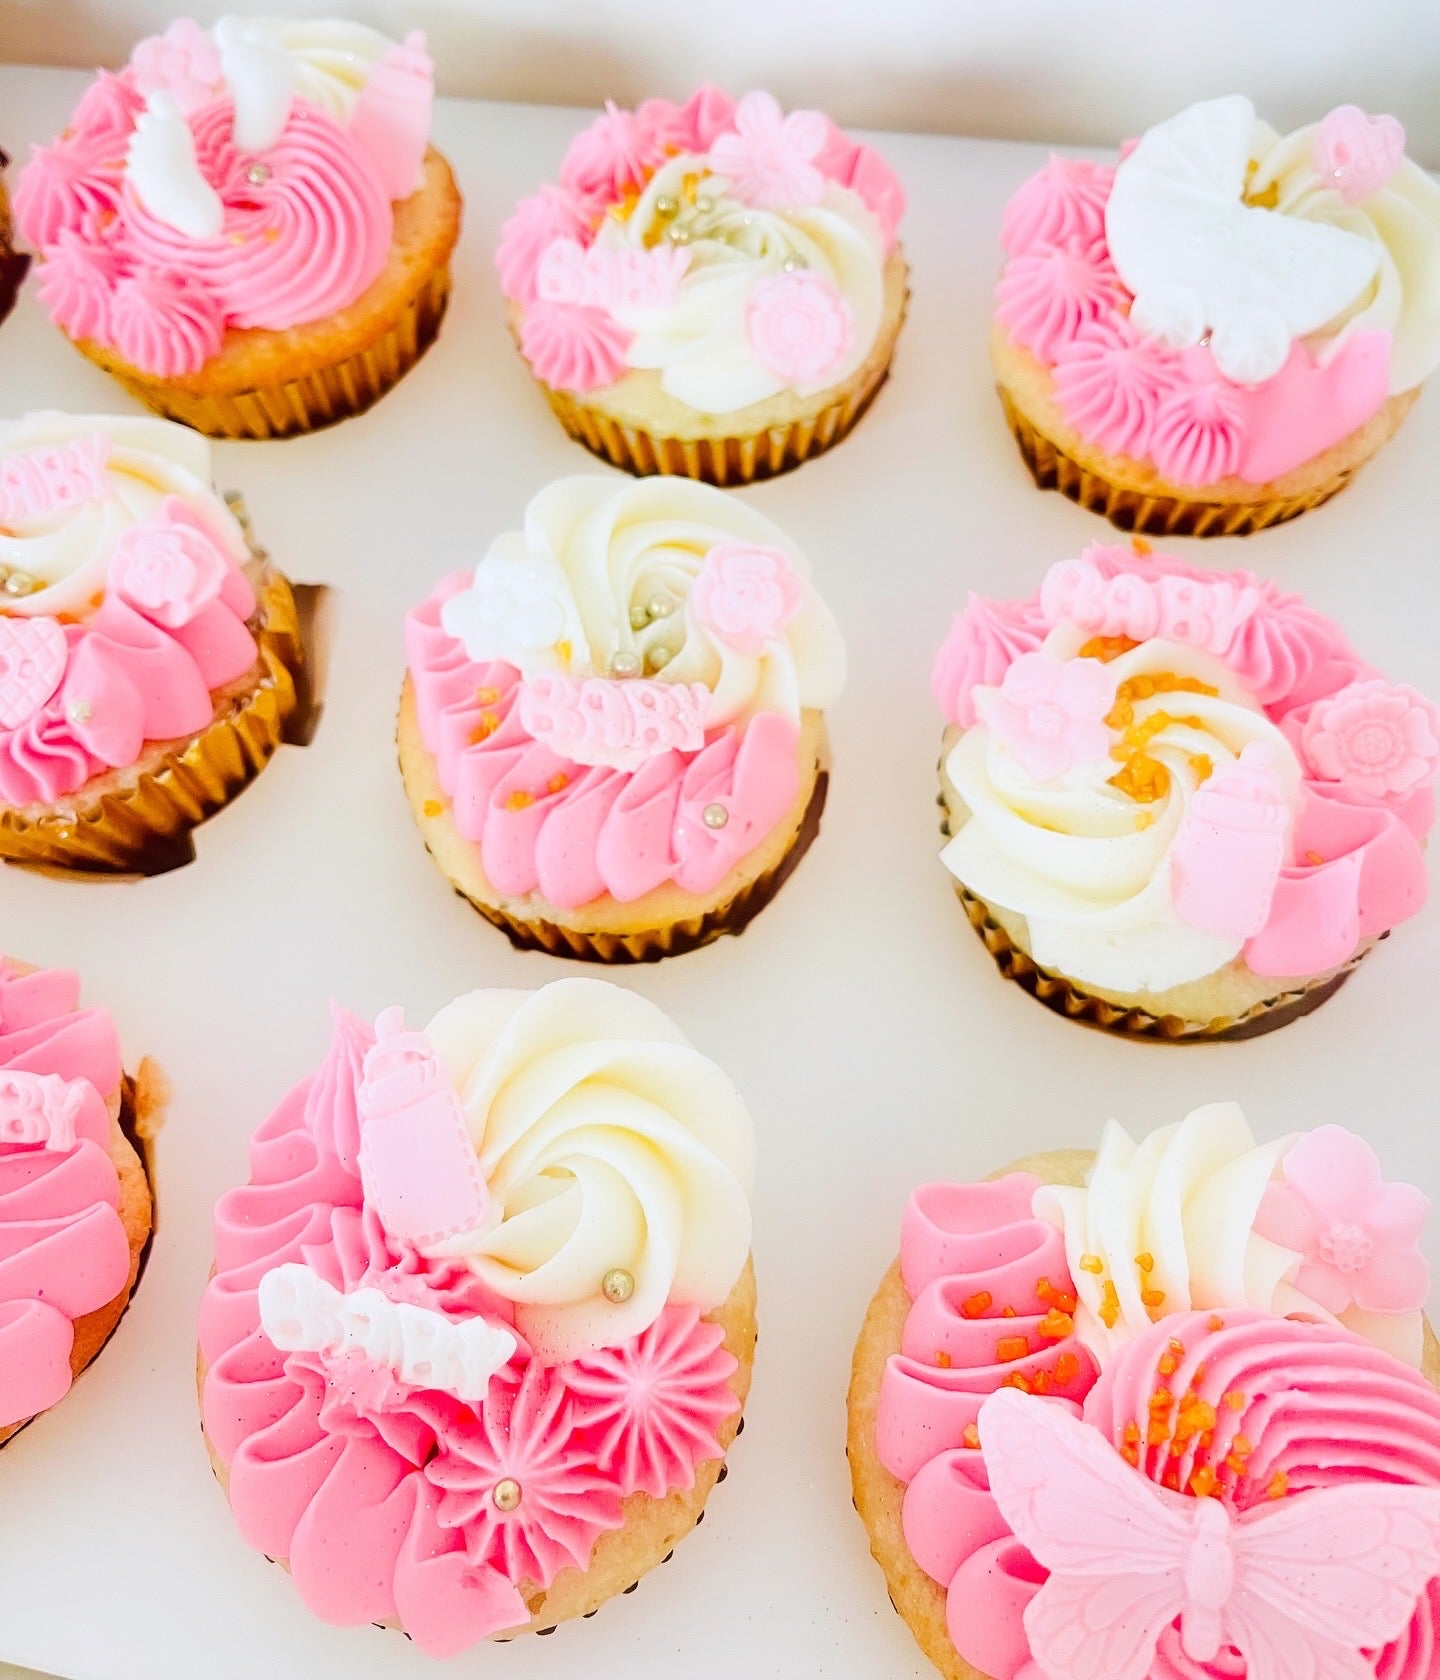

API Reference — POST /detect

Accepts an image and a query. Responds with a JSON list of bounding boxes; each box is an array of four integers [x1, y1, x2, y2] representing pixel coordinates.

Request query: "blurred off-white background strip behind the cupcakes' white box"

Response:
[[0, 0, 1440, 166]]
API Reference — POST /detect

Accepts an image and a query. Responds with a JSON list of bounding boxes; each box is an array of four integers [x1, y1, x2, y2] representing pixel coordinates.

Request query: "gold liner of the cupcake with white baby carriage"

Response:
[[996, 385, 1356, 536]]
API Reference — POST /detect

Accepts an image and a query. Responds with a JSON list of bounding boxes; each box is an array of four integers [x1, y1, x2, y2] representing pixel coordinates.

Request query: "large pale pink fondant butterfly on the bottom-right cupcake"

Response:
[[980, 1389, 1440, 1680]]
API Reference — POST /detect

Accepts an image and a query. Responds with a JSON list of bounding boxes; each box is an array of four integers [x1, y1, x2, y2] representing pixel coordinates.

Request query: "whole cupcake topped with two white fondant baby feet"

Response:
[[15, 17, 460, 438]]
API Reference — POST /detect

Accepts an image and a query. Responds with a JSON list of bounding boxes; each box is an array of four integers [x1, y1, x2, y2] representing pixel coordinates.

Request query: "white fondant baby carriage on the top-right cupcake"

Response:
[[1106, 94, 1380, 385]]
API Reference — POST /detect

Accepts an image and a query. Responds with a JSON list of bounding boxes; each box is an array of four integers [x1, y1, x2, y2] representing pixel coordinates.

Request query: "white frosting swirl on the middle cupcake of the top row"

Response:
[[596, 155, 886, 413]]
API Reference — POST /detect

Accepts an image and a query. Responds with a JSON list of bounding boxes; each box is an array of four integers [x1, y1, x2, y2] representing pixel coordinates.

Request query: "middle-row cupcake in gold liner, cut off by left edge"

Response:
[[0, 413, 302, 872]]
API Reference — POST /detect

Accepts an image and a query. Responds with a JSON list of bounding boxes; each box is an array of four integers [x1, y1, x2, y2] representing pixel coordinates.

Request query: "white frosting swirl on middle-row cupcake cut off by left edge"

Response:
[[0, 410, 249, 617]]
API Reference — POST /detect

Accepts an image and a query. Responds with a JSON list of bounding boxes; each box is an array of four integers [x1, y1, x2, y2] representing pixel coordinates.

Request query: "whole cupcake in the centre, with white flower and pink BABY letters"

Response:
[[398, 477, 845, 963]]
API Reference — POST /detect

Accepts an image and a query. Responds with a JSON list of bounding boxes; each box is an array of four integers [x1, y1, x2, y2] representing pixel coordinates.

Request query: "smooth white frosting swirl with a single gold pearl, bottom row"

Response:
[[418, 979, 754, 1361]]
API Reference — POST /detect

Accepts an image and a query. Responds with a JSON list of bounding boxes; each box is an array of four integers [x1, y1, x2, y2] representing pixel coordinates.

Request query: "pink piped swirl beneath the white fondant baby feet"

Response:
[[126, 99, 393, 331]]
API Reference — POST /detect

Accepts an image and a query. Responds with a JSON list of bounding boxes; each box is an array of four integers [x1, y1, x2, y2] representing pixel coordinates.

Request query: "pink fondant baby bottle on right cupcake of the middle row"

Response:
[[1169, 741, 1290, 939]]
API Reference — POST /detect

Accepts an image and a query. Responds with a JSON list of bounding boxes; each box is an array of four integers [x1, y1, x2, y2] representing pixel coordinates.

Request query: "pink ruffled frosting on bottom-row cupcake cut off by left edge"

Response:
[[0, 959, 129, 1428]]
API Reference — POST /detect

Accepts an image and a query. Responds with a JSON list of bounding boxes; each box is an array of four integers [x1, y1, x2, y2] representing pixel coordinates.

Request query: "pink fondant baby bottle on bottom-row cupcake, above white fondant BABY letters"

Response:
[[356, 1008, 489, 1248]]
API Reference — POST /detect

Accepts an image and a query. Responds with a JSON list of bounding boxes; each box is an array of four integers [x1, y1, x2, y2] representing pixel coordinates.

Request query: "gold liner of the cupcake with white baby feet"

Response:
[[89, 267, 450, 440]]
